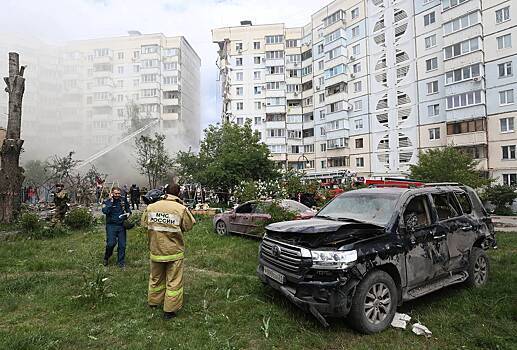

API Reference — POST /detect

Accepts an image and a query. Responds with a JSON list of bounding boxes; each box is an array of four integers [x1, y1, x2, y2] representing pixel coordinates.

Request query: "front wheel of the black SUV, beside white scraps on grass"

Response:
[[348, 270, 398, 334]]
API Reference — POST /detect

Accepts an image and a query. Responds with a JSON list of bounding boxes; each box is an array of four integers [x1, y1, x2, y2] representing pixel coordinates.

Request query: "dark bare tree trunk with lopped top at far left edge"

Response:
[[0, 52, 25, 223]]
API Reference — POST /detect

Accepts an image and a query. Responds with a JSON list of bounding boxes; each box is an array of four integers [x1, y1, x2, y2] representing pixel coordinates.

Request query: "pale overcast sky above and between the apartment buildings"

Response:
[[0, 0, 330, 127]]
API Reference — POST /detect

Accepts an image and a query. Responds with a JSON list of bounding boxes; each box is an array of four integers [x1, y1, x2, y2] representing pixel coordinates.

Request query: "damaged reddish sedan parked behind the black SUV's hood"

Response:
[[213, 199, 316, 236]]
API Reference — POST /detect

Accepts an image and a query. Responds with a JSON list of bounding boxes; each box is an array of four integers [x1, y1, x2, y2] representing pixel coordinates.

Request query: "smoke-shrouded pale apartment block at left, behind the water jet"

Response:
[[0, 31, 201, 159]]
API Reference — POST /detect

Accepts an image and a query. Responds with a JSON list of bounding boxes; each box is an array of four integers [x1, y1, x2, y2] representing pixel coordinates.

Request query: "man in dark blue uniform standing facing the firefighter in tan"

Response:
[[102, 187, 131, 268]]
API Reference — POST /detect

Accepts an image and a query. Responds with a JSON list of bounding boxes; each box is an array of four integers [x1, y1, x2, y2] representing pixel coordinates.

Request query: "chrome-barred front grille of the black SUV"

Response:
[[261, 238, 306, 273]]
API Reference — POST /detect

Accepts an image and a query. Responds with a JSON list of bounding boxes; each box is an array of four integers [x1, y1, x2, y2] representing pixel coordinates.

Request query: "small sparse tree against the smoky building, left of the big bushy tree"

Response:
[[135, 133, 173, 188]]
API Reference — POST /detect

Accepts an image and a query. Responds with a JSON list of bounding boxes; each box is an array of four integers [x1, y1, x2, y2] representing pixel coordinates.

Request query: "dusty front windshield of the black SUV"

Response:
[[316, 191, 400, 226]]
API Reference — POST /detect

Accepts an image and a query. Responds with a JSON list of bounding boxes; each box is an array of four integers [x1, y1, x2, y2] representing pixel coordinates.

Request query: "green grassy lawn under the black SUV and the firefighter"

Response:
[[0, 221, 517, 350]]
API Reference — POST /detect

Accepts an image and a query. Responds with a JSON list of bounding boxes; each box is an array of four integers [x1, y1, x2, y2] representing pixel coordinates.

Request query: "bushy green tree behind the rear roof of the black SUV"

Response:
[[410, 146, 492, 188]]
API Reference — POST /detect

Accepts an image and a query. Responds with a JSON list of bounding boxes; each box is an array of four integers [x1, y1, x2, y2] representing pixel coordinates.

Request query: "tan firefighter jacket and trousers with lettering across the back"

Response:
[[142, 194, 196, 312]]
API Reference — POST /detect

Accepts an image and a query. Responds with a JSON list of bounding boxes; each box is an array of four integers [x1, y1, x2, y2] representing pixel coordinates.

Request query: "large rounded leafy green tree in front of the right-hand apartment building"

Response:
[[176, 121, 279, 196]]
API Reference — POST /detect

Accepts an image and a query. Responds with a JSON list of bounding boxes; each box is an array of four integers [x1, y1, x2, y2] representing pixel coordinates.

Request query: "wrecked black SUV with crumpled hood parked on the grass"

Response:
[[257, 184, 496, 333]]
